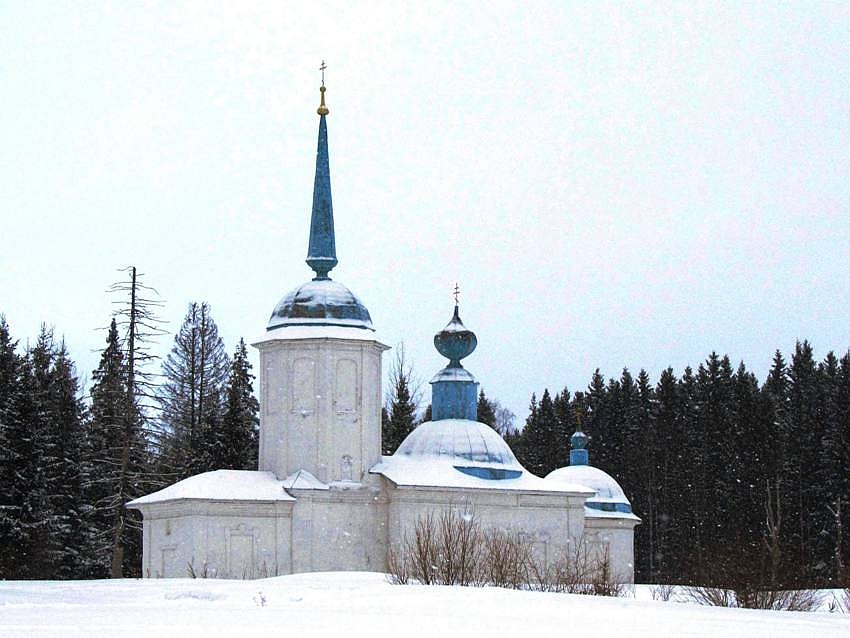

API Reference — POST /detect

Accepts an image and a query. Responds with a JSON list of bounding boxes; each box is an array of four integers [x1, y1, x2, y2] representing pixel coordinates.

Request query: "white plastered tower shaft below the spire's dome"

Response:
[[255, 338, 387, 483]]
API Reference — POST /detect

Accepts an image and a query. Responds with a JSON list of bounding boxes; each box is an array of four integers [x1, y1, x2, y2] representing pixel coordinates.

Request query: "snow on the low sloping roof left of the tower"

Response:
[[127, 470, 295, 507]]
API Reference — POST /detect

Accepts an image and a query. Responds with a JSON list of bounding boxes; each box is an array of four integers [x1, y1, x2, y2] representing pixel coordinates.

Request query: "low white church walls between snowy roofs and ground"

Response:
[[135, 473, 634, 582]]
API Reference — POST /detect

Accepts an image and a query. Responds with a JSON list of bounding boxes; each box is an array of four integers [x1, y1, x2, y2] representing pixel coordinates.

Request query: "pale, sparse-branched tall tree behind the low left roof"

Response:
[[158, 302, 229, 480]]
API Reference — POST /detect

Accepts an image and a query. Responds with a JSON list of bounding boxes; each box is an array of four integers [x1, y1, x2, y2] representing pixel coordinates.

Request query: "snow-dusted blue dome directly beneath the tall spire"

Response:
[[266, 279, 374, 330]]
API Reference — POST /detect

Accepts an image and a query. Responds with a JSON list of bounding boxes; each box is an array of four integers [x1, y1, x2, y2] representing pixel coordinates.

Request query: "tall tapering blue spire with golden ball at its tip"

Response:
[[307, 84, 337, 279]]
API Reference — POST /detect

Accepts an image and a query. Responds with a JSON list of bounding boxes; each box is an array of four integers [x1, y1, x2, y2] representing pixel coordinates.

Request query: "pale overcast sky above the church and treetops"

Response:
[[0, 1, 850, 421]]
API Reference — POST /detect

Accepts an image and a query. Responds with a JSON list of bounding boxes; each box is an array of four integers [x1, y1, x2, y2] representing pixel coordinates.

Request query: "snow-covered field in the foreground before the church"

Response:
[[0, 572, 850, 638]]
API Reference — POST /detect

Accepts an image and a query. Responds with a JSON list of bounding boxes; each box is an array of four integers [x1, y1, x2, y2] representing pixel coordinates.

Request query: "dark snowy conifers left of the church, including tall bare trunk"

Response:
[[0, 268, 259, 579]]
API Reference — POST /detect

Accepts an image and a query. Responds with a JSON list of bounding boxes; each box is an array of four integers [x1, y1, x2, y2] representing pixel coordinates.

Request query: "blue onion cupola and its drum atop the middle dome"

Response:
[[431, 303, 478, 421]]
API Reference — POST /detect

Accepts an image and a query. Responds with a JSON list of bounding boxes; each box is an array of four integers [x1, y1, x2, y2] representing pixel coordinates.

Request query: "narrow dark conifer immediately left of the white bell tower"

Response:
[[212, 339, 260, 470]]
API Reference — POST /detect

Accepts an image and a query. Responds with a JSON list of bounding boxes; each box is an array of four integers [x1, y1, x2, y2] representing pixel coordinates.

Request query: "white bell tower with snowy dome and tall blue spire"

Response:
[[253, 75, 388, 483]]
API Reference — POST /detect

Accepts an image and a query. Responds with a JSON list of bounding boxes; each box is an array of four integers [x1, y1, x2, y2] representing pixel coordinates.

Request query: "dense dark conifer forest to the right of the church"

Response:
[[507, 348, 850, 587]]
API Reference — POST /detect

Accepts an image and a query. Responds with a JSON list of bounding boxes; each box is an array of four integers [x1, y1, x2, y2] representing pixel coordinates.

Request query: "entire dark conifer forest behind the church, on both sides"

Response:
[[0, 284, 850, 587]]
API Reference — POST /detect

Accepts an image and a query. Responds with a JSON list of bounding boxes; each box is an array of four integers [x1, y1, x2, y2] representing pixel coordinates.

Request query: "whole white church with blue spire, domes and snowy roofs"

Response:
[[127, 82, 640, 582]]
